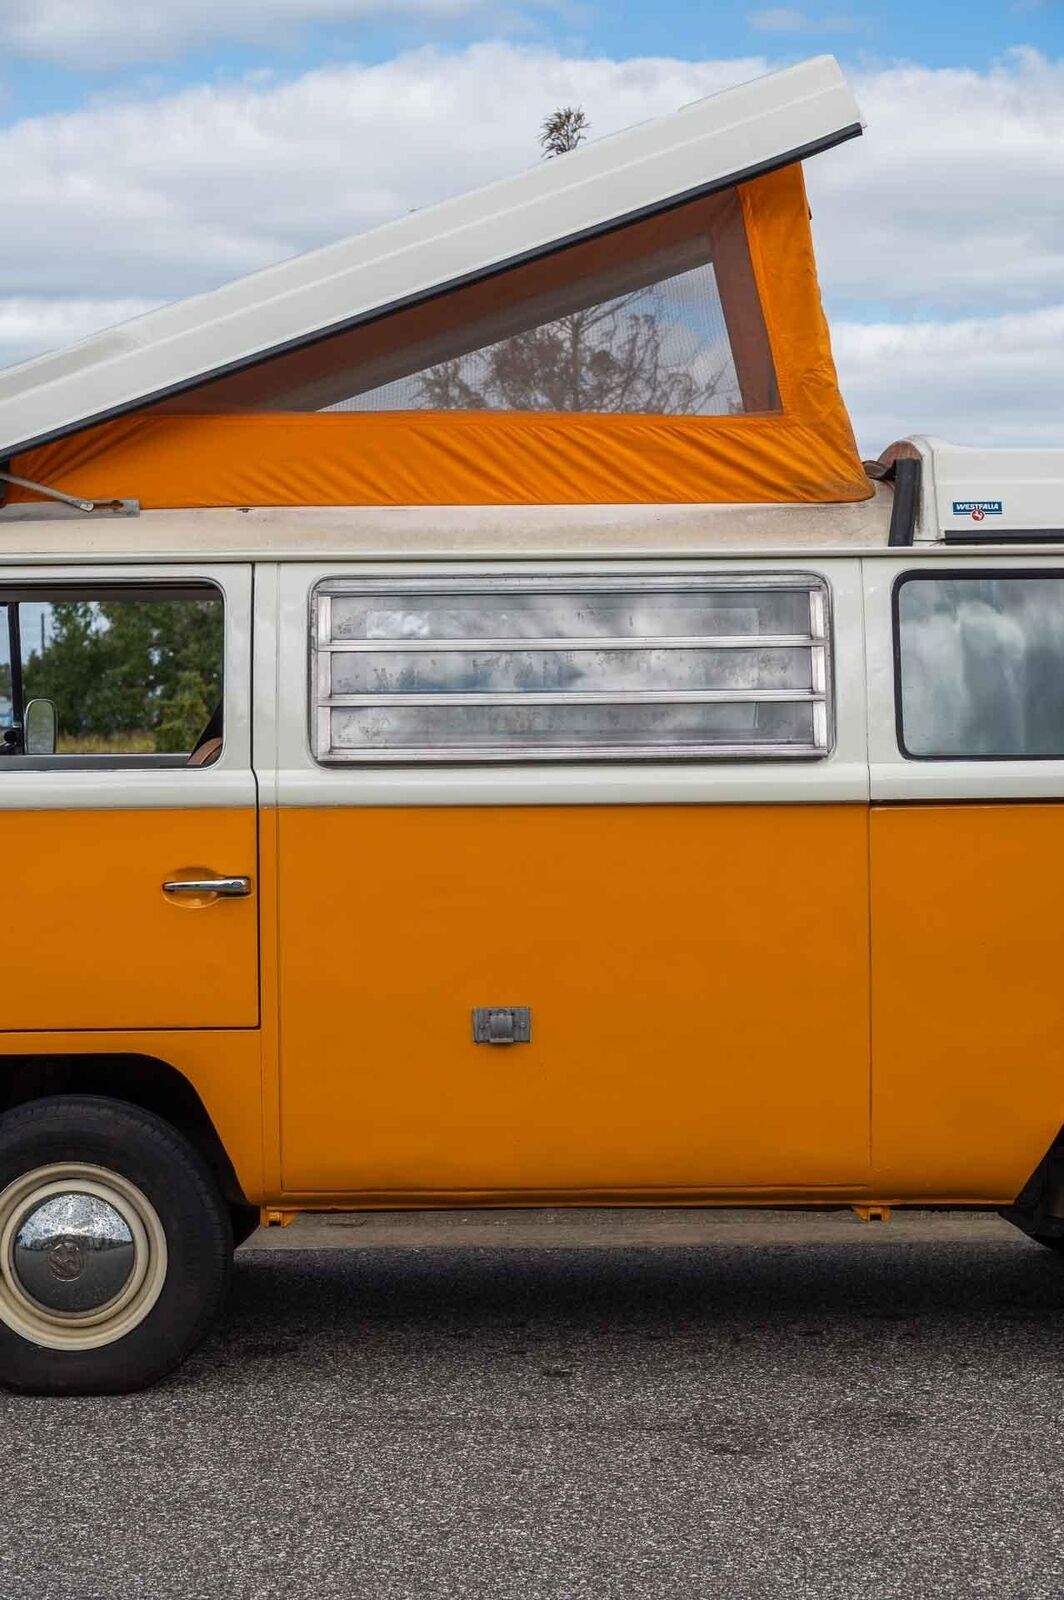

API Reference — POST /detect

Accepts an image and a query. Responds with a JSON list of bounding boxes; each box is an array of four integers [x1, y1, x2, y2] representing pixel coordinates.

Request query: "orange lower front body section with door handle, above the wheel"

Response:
[[0, 806, 266, 1203]]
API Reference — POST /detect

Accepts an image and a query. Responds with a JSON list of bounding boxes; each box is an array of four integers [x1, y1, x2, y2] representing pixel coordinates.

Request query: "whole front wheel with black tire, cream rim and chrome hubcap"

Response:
[[0, 1094, 232, 1394]]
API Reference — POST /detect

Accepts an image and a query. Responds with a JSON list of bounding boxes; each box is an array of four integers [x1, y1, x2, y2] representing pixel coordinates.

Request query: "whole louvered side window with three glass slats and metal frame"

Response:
[[312, 573, 832, 763]]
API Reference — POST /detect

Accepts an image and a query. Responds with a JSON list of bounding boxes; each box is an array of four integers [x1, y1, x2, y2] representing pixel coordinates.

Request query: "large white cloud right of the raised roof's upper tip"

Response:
[[808, 51, 1064, 317]]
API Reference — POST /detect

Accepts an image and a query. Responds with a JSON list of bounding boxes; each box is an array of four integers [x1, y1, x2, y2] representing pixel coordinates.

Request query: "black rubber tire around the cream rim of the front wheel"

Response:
[[0, 1094, 234, 1395]]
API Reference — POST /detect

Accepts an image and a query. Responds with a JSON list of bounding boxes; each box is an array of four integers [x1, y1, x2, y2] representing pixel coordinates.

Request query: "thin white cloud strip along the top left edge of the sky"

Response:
[[0, 0, 550, 70]]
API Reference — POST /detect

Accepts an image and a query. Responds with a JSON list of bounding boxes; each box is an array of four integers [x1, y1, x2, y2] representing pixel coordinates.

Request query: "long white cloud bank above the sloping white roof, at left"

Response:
[[0, 45, 765, 299]]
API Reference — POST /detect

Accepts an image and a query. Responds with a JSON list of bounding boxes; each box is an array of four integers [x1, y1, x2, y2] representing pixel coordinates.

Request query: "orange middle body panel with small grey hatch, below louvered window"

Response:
[[277, 806, 869, 1198]]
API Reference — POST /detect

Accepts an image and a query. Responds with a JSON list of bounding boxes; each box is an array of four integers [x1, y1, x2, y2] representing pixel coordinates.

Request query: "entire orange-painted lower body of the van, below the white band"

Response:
[[0, 803, 1064, 1206]]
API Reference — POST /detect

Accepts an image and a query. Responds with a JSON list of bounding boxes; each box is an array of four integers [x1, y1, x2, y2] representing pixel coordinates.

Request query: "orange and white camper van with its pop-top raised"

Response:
[[0, 61, 1064, 1392]]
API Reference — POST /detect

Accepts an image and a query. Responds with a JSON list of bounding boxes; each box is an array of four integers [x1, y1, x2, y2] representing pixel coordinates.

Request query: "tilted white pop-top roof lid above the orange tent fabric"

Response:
[[0, 56, 862, 461]]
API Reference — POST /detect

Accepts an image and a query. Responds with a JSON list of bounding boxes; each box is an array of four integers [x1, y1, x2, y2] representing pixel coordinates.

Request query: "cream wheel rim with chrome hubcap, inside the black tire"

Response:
[[0, 1162, 166, 1350]]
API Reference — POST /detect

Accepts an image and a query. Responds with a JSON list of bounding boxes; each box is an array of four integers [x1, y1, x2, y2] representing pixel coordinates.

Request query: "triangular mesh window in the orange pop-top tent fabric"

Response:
[[158, 190, 779, 416]]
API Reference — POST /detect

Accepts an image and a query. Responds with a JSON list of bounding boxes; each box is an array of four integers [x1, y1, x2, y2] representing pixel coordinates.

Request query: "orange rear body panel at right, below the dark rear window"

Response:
[[872, 803, 1064, 1203]]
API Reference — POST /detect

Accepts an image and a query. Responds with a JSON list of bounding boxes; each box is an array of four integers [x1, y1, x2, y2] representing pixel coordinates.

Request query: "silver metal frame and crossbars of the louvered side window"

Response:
[[309, 571, 835, 768]]
